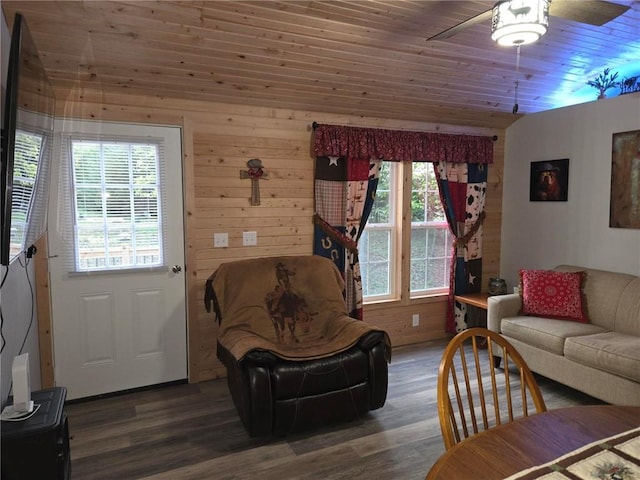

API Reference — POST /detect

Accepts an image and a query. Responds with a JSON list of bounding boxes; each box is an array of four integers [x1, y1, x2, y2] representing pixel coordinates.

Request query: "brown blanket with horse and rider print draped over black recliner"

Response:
[[205, 255, 390, 360]]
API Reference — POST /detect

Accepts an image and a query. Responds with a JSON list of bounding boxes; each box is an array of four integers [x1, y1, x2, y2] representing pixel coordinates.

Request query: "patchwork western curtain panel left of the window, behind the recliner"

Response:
[[313, 156, 382, 320]]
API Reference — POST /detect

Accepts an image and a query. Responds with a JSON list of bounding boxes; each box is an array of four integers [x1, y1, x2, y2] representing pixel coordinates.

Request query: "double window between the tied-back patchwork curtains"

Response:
[[360, 162, 453, 302]]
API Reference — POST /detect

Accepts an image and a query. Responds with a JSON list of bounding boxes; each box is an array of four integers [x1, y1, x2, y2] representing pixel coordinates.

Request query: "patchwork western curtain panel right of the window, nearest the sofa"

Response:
[[434, 162, 488, 333]]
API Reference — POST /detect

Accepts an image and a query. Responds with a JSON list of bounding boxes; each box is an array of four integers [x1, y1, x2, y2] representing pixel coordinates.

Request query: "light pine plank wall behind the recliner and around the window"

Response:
[[57, 91, 504, 382]]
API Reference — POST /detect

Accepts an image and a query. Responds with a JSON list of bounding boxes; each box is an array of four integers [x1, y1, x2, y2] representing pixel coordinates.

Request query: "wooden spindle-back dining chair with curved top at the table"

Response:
[[437, 328, 547, 450]]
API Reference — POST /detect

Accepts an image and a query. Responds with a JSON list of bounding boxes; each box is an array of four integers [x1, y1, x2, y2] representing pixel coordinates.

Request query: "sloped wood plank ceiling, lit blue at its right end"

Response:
[[2, 0, 640, 126]]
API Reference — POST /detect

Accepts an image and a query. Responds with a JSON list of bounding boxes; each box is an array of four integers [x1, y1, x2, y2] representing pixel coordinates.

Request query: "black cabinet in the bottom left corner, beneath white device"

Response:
[[1, 387, 71, 480]]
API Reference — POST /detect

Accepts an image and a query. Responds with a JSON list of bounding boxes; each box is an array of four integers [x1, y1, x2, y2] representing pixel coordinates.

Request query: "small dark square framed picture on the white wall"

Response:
[[529, 158, 569, 202]]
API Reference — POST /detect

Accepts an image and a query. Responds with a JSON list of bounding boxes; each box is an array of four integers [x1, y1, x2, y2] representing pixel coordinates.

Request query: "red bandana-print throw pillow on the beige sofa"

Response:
[[520, 270, 589, 322]]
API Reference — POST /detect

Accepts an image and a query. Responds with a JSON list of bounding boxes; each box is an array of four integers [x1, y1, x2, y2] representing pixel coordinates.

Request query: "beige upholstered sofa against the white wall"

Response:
[[487, 265, 640, 406]]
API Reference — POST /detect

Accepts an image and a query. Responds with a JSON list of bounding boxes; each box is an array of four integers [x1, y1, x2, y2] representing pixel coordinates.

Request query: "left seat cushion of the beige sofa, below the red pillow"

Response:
[[500, 317, 607, 355]]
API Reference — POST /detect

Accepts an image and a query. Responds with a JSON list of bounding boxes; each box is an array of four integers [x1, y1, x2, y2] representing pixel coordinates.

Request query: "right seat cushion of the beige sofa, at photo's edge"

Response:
[[564, 332, 640, 382]]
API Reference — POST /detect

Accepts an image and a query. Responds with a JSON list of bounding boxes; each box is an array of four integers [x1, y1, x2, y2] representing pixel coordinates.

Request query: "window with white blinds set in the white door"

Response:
[[70, 139, 163, 271]]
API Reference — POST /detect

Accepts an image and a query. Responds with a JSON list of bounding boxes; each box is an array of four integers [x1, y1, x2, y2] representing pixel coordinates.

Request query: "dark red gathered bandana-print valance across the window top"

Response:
[[313, 124, 493, 163]]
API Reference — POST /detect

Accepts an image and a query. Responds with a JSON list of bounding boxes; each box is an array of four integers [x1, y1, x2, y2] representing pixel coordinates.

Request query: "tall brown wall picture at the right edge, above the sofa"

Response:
[[609, 130, 640, 228]]
